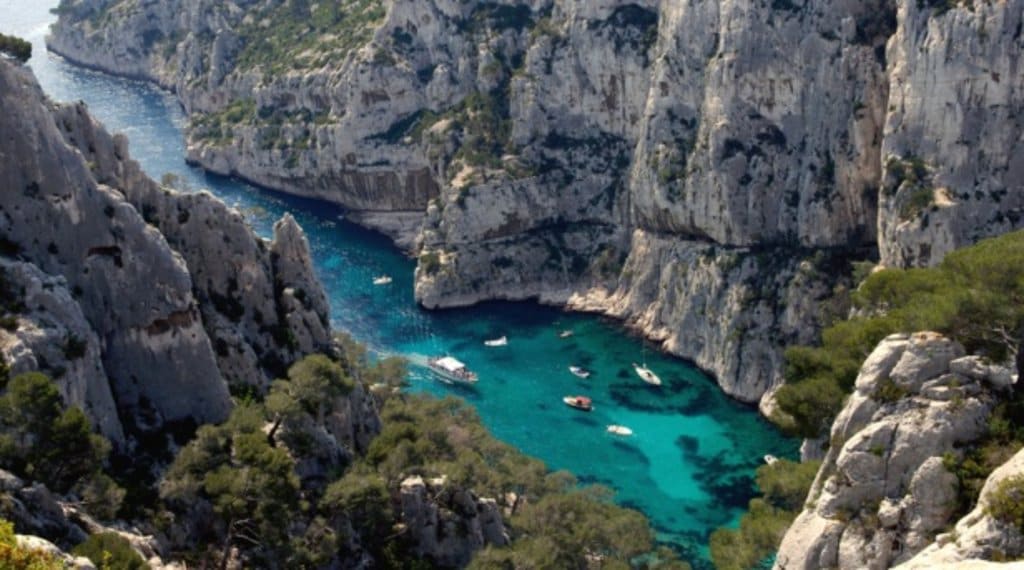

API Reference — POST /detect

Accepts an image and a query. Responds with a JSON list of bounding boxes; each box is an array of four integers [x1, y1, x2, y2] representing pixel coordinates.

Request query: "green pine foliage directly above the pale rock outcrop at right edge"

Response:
[[776, 231, 1024, 438]]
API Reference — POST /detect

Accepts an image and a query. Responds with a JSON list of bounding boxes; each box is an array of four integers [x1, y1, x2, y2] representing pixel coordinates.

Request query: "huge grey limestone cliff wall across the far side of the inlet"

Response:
[[49, 0, 1024, 401]]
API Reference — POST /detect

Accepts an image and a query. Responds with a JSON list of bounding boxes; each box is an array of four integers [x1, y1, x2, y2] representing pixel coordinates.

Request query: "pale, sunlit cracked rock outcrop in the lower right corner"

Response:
[[775, 333, 1021, 570]]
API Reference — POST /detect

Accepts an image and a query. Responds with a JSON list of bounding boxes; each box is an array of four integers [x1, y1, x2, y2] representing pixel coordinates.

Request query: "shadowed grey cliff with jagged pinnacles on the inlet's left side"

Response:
[[0, 55, 330, 444]]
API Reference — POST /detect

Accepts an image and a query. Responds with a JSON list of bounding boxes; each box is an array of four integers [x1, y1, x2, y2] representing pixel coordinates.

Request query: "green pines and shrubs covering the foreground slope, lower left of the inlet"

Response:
[[0, 329, 687, 570]]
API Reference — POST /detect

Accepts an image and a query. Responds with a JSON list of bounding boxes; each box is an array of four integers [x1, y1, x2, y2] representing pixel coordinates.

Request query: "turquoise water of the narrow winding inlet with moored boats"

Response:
[[0, 0, 797, 566]]
